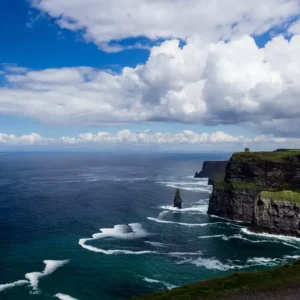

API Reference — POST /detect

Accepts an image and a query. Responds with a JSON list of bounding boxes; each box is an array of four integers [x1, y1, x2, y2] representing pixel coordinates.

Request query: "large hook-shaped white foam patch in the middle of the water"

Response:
[[78, 223, 156, 255]]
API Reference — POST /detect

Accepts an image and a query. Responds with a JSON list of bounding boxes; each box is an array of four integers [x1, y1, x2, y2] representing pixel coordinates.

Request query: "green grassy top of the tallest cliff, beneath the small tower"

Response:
[[231, 150, 300, 161]]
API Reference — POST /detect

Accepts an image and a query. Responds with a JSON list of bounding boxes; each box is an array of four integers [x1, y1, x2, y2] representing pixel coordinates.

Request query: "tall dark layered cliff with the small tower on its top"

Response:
[[208, 151, 300, 222]]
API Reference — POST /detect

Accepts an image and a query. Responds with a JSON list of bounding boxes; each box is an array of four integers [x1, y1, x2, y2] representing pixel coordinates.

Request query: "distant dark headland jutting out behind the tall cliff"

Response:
[[195, 161, 228, 185]]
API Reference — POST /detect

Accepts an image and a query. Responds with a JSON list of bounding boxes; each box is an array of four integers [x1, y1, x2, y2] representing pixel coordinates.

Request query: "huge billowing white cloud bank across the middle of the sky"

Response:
[[0, 32, 300, 136]]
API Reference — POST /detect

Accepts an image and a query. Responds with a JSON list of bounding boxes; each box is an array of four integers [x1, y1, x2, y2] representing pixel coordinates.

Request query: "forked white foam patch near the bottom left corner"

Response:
[[25, 260, 69, 294]]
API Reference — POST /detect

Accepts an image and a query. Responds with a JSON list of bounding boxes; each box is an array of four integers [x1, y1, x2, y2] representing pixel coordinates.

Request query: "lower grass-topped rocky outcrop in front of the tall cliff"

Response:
[[251, 191, 300, 237]]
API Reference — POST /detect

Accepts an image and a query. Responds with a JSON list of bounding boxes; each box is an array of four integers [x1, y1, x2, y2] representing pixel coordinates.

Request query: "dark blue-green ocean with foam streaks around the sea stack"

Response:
[[0, 153, 300, 300]]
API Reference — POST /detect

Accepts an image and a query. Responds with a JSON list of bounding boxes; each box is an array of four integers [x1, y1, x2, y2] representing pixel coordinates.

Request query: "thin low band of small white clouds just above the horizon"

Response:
[[0, 130, 300, 148]]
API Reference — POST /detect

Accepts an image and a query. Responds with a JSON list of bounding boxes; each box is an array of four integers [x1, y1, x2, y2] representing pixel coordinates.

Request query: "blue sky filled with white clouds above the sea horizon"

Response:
[[0, 0, 300, 152]]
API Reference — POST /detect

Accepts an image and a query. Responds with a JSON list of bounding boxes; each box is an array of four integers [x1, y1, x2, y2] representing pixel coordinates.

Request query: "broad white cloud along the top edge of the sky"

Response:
[[31, 0, 300, 51]]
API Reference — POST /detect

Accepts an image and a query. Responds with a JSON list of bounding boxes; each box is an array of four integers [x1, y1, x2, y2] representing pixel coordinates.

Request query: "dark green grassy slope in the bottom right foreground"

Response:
[[133, 260, 300, 300]]
